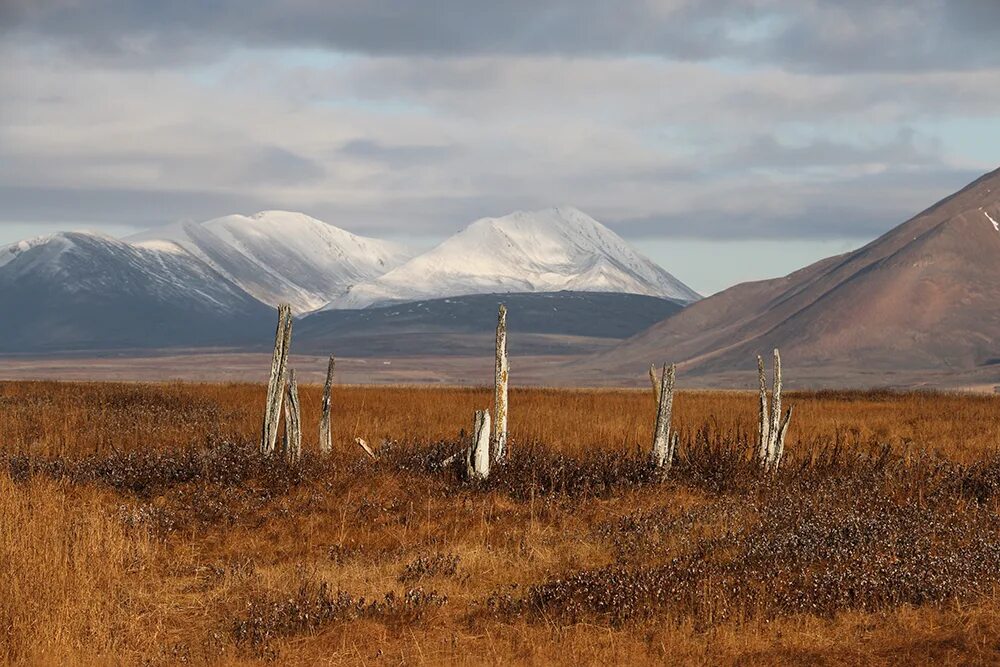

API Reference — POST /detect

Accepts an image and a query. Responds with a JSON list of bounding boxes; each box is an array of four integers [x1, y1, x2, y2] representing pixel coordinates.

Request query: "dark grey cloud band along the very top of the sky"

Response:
[[7, 0, 1000, 71]]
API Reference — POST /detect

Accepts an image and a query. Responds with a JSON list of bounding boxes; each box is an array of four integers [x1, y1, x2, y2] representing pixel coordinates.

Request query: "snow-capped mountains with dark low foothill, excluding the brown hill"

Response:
[[0, 208, 698, 355]]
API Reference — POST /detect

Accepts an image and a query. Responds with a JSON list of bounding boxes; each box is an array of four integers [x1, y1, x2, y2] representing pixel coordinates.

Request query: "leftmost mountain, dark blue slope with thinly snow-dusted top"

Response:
[[0, 232, 273, 351]]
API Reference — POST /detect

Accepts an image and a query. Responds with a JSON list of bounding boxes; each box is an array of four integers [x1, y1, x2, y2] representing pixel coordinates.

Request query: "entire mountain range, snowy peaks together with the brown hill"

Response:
[[0, 170, 1000, 387]]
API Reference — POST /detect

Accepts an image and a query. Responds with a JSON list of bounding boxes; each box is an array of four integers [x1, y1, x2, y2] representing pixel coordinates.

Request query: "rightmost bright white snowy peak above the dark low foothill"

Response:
[[325, 207, 700, 310]]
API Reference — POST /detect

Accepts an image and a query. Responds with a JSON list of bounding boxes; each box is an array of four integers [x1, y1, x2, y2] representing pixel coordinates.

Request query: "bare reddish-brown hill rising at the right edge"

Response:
[[579, 170, 1000, 385]]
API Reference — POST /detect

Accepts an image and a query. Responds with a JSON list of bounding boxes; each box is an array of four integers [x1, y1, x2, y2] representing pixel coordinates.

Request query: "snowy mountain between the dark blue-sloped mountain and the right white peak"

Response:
[[127, 211, 412, 313]]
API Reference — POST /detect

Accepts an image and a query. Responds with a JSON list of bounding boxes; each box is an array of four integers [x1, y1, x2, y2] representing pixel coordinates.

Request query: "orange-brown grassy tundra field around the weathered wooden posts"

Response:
[[0, 382, 1000, 665]]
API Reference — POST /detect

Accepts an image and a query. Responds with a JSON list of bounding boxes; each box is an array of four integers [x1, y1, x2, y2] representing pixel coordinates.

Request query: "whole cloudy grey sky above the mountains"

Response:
[[0, 0, 1000, 293]]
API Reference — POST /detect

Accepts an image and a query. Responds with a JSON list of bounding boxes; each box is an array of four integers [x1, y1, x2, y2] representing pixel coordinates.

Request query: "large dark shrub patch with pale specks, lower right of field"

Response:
[[487, 447, 1000, 627]]
